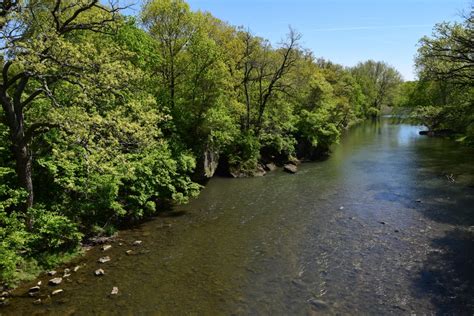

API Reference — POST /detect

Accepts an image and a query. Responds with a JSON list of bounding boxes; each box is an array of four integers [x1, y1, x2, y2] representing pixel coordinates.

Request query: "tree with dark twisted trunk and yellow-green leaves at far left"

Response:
[[0, 0, 121, 212]]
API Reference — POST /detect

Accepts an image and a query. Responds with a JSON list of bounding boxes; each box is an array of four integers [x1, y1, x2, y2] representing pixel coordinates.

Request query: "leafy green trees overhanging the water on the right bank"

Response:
[[399, 8, 474, 145]]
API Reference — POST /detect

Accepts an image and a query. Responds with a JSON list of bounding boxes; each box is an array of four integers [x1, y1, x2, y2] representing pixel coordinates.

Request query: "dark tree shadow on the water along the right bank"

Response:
[[414, 131, 474, 315]]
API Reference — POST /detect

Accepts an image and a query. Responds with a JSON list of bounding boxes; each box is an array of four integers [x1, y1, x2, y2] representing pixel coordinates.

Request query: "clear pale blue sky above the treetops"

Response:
[[123, 0, 474, 80]]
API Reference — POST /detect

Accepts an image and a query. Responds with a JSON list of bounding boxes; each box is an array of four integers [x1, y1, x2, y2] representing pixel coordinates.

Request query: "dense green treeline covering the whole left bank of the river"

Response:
[[0, 0, 473, 284]]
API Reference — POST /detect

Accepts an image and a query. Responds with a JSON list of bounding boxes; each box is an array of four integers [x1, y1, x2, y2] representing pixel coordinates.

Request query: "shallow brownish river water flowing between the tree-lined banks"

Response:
[[0, 119, 474, 315]]
